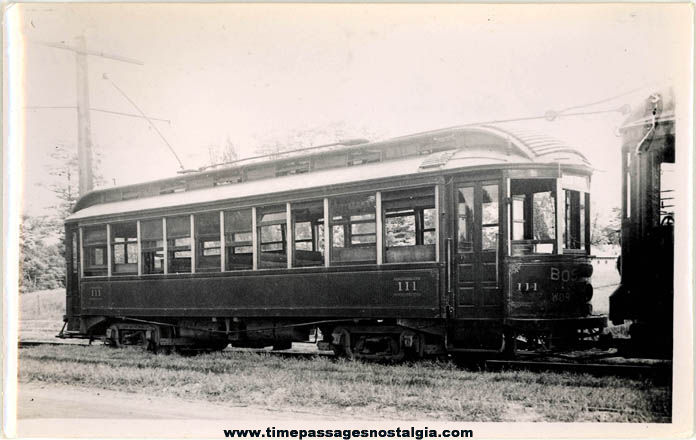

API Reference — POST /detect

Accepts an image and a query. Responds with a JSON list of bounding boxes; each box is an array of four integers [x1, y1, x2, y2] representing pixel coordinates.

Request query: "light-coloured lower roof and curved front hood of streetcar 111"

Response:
[[66, 126, 589, 221]]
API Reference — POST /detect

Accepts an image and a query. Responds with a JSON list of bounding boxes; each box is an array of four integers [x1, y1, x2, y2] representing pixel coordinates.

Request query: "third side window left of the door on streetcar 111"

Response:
[[292, 200, 324, 267]]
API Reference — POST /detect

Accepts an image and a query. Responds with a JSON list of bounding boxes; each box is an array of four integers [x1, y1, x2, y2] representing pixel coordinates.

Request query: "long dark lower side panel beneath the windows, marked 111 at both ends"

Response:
[[81, 265, 441, 318]]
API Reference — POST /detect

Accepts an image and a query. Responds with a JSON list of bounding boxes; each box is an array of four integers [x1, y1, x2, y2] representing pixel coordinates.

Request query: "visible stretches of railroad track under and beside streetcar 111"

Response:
[[19, 340, 672, 383]]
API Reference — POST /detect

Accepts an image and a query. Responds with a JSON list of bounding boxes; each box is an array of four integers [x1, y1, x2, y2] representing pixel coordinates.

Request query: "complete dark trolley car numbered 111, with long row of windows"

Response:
[[62, 125, 606, 359]]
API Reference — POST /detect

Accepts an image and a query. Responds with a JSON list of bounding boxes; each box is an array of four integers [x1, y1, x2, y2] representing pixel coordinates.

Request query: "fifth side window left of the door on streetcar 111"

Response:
[[225, 209, 254, 270]]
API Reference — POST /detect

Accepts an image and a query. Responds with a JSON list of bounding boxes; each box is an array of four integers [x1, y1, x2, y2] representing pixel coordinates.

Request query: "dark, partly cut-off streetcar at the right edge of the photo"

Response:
[[609, 89, 675, 358]]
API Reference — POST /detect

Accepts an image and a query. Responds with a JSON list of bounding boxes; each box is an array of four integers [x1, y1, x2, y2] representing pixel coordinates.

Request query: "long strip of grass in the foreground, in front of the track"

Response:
[[19, 346, 671, 422]]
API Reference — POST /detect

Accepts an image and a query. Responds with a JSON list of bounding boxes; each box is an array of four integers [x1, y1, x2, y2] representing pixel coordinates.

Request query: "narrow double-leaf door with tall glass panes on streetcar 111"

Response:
[[454, 182, 502, 318]]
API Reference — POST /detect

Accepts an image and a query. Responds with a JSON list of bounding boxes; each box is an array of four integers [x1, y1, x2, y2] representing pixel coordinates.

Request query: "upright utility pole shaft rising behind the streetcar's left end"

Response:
[[75, 35, 94, 196]]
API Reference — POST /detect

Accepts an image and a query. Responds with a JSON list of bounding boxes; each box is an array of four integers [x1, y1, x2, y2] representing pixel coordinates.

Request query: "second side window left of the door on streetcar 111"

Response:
[[330, 194, 377, 264]]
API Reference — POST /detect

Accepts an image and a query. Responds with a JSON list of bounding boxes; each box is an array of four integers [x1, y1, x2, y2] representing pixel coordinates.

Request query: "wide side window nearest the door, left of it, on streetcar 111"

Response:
[[382, 188, 436, 263]]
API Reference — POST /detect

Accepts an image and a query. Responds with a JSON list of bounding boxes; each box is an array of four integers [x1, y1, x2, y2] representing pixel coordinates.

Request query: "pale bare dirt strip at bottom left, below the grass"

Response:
[[17, 383, 354, 437]]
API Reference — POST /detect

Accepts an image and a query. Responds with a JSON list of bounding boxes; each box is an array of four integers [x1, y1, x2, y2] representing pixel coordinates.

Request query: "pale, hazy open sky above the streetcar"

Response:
[[9, 4, 691, 223]]
